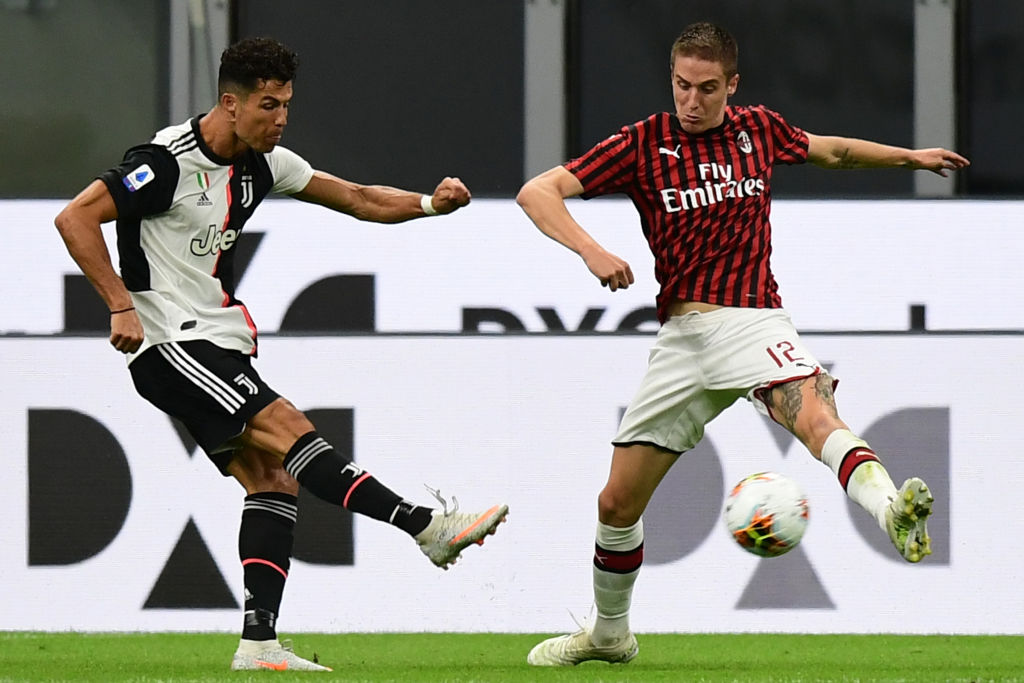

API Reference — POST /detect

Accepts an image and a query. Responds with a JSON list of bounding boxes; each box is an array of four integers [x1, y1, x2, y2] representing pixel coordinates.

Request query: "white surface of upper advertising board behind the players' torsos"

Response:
[[0, 199, 1024, 334]]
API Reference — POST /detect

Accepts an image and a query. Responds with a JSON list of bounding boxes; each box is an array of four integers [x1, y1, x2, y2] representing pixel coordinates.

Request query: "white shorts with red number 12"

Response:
[[612, 308, 824, 453]]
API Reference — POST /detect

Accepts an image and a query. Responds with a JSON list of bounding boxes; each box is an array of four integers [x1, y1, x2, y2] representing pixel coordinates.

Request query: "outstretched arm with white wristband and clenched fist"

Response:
[[292, 171, 471, 223]]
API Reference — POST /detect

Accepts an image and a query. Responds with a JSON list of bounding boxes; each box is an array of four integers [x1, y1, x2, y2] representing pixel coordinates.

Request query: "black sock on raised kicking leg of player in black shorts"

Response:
[[285, 432, 430, 536]]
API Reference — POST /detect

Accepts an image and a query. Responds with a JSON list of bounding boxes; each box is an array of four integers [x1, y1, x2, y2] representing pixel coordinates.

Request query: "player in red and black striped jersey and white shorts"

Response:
[[517, 23, 969, 666]]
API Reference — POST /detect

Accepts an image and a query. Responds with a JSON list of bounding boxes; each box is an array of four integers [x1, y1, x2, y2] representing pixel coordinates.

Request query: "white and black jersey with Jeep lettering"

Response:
[[99, 117, 313, 362]]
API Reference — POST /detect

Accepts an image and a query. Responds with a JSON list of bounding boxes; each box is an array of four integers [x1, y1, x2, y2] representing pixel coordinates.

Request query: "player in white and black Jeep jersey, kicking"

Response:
[[55, 38, 508, 671]]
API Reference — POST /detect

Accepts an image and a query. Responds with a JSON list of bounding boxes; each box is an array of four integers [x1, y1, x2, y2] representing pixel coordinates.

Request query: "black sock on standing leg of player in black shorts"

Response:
[[239, 492, 298, 640]]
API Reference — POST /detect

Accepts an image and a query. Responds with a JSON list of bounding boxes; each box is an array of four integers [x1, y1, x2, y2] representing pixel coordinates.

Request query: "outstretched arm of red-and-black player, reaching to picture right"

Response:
[[807, 133, 971, 177]]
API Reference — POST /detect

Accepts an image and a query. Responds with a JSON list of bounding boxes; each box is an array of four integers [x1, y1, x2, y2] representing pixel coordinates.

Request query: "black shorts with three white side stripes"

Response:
[[128, 340, 279, 475]]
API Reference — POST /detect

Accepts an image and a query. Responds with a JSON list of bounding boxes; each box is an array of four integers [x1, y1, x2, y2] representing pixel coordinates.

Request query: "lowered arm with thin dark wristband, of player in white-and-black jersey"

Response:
[[53, 180, 143, 353]]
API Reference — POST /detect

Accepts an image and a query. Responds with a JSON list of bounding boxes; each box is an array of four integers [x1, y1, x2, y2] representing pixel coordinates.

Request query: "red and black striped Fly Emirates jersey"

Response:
[[565, 105, 808, 323]]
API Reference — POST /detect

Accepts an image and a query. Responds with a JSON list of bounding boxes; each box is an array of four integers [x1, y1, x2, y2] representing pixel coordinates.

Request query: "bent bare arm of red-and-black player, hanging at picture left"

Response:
[[516, 166, 634, 292]]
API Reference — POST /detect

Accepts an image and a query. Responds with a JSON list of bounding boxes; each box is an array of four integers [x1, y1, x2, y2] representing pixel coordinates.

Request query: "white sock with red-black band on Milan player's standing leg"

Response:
[[590, 519, 643, 646]]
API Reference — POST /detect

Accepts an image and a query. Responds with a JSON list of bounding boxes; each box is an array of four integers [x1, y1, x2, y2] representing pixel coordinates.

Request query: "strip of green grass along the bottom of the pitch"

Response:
[[0, 632, 1024, 683]]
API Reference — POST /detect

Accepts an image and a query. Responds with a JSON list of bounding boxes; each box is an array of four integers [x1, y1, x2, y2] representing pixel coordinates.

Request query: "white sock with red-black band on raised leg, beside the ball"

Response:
[[821, 429, 896, 531]]
